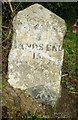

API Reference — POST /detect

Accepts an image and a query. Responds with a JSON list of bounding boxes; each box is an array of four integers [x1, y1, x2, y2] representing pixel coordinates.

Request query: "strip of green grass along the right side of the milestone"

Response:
[[62, 24, 78, 92]]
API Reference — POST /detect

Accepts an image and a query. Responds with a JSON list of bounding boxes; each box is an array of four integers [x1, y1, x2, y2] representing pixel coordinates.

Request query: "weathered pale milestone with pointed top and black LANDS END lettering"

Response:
[[8, 4, 66, 106]]
